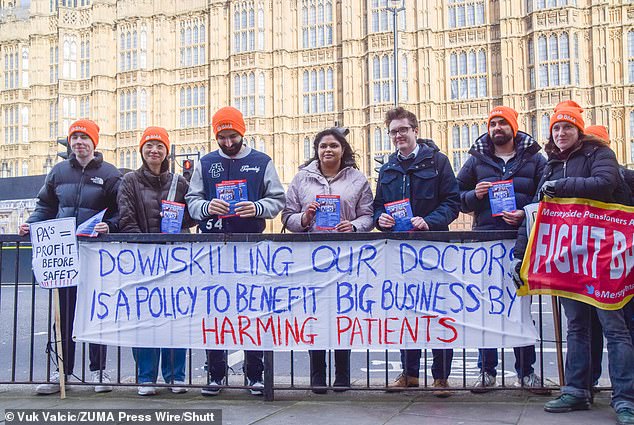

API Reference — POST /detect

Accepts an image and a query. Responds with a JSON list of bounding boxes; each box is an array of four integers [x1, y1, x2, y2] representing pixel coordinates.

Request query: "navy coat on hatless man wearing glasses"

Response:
[[374, 139, 460, 230]]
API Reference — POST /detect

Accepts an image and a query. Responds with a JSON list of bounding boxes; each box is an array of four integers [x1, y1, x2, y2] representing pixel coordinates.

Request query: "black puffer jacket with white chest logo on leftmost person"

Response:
[[27, 152, 121, 232]]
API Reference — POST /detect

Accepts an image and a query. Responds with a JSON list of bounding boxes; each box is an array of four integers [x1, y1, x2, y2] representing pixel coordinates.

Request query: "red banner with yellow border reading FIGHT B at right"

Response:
[[518, 199, 634, 310]]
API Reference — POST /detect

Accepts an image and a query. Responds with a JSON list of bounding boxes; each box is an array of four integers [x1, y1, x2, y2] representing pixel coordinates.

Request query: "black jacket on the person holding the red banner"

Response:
[[514, 140, 627, 259]]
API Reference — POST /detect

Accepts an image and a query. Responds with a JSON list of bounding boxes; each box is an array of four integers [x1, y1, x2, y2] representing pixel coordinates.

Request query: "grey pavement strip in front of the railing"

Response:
[[0, 384, 616, 425]]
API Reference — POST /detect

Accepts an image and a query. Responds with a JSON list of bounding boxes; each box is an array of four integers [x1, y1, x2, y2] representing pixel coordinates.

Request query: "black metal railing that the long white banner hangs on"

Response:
[[0, 231, 584, 400]]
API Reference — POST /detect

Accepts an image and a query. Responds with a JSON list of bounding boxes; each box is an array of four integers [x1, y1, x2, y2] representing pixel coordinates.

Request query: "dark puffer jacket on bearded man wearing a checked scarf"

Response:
[[457, 131, 546, 230]]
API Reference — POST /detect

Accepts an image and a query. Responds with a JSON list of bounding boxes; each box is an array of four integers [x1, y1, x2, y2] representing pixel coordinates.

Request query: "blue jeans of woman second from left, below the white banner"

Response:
[[132, 348, 187, 384]]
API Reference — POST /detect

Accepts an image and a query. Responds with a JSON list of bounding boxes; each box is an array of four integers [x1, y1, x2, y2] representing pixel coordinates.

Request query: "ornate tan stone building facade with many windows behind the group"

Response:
[[0, 0, 634, 229]]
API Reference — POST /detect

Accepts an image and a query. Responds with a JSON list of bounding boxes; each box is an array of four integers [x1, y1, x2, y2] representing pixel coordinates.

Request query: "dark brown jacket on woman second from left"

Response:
[[117, 160, 196, 233]]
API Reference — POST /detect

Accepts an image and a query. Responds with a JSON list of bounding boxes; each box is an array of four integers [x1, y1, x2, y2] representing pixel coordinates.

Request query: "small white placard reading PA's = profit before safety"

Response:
[[29, 217, 79, 289]]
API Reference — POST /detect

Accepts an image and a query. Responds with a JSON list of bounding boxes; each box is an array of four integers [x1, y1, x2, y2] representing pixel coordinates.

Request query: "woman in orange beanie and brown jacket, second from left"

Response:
[[117, 127, 195, 396]]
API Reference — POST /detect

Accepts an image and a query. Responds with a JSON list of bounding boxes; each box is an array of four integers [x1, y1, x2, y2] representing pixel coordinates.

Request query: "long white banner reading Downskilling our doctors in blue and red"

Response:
[[74, 240, 537, 351]]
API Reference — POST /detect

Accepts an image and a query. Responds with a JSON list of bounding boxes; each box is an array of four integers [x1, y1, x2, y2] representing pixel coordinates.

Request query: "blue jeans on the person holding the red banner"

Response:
[[561, 298, 634, 412]]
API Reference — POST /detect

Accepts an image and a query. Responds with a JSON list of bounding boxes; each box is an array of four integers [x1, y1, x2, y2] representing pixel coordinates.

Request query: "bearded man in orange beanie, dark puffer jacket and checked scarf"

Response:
[[457, 106, 550, 394]]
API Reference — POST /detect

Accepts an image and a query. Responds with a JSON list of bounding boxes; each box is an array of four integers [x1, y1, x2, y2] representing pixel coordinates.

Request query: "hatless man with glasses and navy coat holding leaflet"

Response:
[[374, 107, 460, 397]]
